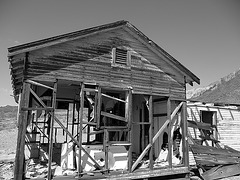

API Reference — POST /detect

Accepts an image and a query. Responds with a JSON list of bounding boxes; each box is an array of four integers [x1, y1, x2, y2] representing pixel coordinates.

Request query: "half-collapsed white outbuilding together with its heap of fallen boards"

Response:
[[187, 102, 240, 180]]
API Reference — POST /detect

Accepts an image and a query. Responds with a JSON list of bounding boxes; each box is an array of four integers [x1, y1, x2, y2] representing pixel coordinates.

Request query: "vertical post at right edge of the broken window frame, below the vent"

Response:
[[126, 89, 132, 172]]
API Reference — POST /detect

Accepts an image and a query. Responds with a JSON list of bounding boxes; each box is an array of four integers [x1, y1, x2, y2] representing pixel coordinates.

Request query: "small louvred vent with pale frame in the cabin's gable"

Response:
[[112, 48, 131, 68]]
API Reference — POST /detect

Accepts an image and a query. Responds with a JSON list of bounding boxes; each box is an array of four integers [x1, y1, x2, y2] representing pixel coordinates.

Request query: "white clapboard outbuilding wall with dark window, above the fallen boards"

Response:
[[187, 102, 240, 151]]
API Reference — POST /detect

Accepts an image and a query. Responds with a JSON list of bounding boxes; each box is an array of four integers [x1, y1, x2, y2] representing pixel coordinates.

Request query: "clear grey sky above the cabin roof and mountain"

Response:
[[0, 0, 240, 106]]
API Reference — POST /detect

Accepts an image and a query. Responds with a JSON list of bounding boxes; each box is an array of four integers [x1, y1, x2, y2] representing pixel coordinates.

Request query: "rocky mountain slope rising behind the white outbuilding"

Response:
[[187, 69, 240, 105]]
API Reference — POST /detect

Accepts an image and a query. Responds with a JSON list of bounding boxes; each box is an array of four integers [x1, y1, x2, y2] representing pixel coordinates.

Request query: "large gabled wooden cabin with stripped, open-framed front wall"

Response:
[[8, 21, 200, 180]]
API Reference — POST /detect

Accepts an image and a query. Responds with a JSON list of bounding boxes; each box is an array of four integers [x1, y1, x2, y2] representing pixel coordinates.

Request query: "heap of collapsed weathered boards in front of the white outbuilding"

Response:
[[188, 121, 240, 180]]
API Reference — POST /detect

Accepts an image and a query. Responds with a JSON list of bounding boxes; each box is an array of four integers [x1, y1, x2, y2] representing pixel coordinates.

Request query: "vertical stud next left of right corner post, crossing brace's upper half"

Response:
[[167, 97, 173, 168]]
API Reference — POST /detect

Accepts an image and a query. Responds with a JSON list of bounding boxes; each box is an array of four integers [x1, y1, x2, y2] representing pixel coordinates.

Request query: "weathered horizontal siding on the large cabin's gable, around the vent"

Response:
[[10, 29, 185, 99]]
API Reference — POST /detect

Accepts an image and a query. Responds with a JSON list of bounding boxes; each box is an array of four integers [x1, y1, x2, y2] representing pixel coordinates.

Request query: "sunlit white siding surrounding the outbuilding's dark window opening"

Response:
[[187, 105, 240, 151]]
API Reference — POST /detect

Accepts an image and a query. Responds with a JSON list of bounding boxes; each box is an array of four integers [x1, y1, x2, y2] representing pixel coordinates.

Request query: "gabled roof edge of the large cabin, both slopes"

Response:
[[8, 20, 200, 84]]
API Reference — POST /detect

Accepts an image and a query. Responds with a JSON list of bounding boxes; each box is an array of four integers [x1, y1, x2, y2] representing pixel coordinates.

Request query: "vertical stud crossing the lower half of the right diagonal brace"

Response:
[[148, 95, 153, 170]]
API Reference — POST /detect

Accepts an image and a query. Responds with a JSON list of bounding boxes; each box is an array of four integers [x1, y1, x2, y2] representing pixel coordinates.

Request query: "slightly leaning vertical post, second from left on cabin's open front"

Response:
[[48, 81, 57, 180]]
